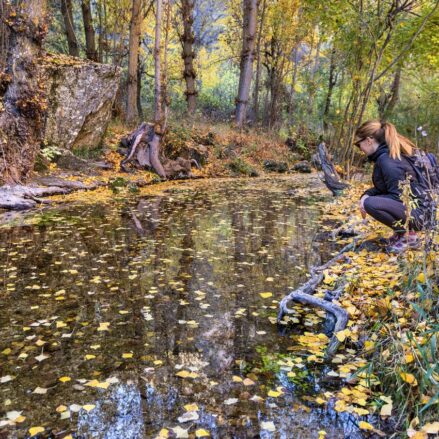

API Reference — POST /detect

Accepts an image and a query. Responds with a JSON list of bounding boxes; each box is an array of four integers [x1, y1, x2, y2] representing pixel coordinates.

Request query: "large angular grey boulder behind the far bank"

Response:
[[42, 54, 120, 150]]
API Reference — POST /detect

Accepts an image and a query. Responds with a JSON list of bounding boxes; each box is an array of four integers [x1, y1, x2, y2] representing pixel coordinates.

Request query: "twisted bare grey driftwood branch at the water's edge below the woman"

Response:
[[277, 241, 356, 359]]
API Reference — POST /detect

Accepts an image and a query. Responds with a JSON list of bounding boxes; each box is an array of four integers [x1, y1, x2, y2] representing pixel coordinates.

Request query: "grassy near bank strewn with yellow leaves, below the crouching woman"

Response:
[[302, 187, 439, 439]]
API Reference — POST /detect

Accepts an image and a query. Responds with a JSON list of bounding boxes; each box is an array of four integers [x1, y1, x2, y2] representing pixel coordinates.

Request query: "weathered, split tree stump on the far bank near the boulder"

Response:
[[120, 122, 200, 179]]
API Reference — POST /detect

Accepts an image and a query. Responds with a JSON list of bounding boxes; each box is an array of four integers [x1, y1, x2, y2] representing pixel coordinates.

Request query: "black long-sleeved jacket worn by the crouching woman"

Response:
[[362, 143, 417, 201]]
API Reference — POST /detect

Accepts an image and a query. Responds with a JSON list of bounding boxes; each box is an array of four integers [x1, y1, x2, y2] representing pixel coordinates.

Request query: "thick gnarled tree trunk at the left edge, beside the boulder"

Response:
[[0, 0, 47, 183]]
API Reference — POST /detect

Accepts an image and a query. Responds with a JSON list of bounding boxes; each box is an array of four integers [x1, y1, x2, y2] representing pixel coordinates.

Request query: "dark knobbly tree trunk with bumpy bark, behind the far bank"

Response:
[[180, 0, 197, 115]]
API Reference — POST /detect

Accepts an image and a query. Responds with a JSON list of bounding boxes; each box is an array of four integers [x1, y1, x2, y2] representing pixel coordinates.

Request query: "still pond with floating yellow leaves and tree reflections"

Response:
[[0, 177, 362, 439]]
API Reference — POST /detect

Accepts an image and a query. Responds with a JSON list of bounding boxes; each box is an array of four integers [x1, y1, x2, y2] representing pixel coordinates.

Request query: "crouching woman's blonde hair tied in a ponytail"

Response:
[[355, 120, 415, 160]]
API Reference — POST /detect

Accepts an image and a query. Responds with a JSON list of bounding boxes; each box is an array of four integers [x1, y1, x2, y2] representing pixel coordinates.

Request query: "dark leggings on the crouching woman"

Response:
[[364, 196, 422, 233]]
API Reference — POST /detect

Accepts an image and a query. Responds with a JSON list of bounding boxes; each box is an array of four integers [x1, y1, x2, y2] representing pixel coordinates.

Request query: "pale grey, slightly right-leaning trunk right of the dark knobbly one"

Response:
[[235, 0, 258, 128]]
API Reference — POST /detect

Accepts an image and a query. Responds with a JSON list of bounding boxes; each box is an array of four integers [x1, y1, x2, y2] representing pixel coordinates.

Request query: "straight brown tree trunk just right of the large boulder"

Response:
[[126, 0, 142, 125]]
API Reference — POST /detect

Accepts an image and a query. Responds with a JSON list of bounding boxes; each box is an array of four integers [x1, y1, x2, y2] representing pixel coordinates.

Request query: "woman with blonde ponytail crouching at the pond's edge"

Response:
[[355, 120, 425, 253]]
